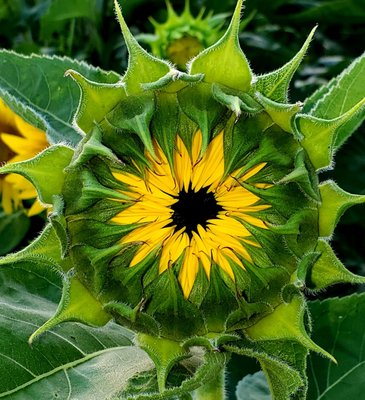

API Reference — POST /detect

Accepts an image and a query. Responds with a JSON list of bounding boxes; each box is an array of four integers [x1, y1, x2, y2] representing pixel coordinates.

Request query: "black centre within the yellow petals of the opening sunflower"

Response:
[[171, 187, 223, 237]]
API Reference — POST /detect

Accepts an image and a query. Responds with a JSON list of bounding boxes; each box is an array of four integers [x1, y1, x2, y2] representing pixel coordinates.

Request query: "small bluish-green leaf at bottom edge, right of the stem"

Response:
[[236, 371, 271, 400]]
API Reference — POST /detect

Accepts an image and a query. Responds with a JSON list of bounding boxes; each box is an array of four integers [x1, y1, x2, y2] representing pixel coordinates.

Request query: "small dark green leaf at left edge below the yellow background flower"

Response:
[[0, 210, 30, 256]]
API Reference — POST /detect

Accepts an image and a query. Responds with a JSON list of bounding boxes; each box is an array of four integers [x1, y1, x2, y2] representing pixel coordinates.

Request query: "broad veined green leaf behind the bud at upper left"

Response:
[[0, 50, 120, 145]]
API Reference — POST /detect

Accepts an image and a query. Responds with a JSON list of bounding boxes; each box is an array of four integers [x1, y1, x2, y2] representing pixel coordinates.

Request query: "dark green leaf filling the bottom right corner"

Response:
[[308, 293, 365, 400]]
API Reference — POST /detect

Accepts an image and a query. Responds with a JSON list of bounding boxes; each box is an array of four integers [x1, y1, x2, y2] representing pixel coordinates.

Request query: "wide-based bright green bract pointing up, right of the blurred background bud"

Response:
[[189, 0, 252, 92]]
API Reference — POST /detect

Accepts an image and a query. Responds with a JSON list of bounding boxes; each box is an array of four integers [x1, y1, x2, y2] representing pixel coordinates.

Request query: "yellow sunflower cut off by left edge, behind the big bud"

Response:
[[0, 99, 49, 216]]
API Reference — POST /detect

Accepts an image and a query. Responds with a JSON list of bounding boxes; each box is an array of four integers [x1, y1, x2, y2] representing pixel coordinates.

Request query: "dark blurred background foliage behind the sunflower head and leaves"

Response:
[[0, 0, 365, 396]]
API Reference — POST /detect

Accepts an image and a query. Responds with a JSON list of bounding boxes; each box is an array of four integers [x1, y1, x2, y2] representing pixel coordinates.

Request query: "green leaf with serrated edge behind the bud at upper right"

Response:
[[304, 53, 365, 149]]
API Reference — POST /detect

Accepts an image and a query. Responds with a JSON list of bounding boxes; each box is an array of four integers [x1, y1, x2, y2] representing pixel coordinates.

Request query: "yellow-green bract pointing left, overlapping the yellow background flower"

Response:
[[0, 145, 74, 204]]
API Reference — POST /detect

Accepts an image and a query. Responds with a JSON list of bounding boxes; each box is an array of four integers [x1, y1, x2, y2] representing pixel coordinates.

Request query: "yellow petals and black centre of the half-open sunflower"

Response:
[[112, 131, 270, 298]]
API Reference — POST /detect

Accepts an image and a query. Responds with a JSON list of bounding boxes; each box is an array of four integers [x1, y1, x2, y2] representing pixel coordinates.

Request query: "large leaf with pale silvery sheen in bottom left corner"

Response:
[[0, 269, 153, 400]]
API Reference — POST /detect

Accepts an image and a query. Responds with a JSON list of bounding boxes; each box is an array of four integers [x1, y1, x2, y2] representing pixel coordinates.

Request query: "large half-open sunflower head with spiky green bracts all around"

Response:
[[0, 0, 365, 399]]
